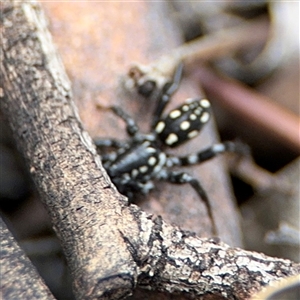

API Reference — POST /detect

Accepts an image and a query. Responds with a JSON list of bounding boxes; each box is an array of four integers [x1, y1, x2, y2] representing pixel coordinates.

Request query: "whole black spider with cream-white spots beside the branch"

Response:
[[94, 65, 244, 233]]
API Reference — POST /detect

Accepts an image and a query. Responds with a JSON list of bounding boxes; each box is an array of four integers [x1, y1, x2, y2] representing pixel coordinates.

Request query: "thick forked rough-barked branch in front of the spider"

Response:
[[0, 0, 300, 299]]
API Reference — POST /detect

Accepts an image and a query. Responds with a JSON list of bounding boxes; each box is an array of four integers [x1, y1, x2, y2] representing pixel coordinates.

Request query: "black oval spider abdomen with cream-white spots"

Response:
[[154, 99, 210, 147]]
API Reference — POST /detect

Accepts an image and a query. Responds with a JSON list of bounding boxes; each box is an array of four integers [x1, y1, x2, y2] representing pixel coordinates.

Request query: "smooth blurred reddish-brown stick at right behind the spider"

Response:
[[193, 68, 300, 153]]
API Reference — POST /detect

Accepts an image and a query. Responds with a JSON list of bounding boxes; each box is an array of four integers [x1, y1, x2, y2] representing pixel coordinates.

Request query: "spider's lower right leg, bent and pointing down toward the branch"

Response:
[[157, 171, 217, 235]]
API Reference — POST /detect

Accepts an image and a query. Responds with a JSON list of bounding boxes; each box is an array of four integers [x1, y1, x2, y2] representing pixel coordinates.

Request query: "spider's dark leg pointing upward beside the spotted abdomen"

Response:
[[152, 63, 183, 128]]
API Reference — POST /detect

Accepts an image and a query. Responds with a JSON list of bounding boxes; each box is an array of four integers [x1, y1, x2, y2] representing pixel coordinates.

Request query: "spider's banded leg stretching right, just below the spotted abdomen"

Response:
[[169, 141, 249, 166]]
